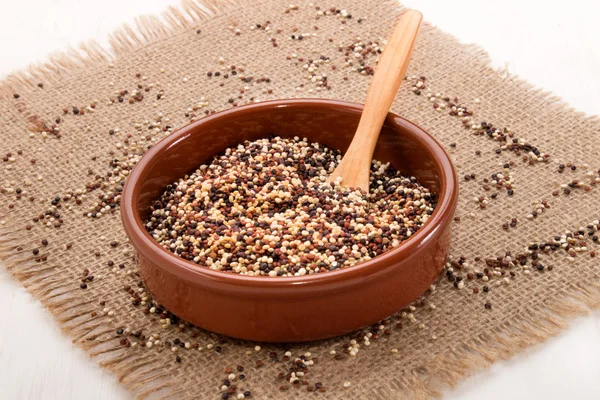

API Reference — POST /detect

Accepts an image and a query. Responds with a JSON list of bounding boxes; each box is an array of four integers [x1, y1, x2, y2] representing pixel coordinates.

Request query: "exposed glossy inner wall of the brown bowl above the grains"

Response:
[[137, 100, 446, 221]]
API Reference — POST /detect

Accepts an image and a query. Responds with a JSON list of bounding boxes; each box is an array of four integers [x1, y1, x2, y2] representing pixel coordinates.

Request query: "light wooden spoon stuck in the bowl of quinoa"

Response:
[[327, 10, 423, 193]]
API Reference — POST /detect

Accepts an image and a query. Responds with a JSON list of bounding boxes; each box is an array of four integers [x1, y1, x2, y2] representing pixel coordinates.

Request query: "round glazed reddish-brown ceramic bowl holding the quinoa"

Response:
[[121, 99, 458, 342]]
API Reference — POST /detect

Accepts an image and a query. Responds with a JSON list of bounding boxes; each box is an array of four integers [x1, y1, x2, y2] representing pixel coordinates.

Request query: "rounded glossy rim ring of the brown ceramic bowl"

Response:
[[121, 98, 458, 290]]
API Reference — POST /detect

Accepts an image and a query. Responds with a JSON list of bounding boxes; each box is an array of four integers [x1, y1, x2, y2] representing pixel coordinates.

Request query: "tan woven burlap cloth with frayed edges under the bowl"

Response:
[[0, 0, 600, 399]]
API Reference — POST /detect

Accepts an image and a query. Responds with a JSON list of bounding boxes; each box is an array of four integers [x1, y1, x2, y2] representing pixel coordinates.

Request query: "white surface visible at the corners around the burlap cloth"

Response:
[[0, 0, 600, 400]]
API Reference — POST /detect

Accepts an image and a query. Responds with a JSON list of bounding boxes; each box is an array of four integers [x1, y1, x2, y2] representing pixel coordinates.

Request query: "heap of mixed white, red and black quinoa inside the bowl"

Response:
[[146, 137, 436, 276]]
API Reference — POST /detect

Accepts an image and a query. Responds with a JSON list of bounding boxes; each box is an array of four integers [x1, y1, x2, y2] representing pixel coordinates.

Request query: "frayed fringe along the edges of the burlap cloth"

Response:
[[0, 0, 600, 400]]
